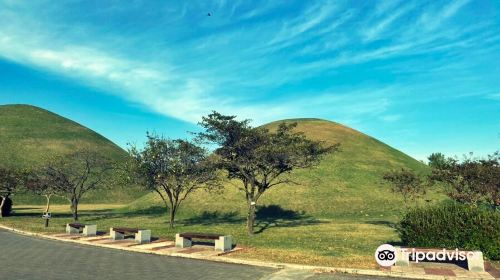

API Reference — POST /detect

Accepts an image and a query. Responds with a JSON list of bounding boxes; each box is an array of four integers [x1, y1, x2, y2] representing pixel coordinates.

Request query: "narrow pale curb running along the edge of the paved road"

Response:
[[0, 224, 472, 280]]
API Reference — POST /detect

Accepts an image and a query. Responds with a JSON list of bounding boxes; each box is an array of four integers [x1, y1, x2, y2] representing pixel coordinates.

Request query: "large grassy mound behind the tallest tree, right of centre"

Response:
[[130, 119, 439, 219]]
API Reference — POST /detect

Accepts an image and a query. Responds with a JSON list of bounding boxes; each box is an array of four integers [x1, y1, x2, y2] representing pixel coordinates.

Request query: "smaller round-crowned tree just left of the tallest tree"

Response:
[[129, 134, 219, 228]]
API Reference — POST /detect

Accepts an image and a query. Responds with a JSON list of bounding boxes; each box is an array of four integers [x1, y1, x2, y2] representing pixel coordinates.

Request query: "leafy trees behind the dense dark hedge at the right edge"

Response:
[[383, 152, 500, 209]]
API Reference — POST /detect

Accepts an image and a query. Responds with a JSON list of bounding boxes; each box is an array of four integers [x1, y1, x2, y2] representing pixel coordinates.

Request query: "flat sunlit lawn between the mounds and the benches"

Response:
[[0, 204, 398, 268]]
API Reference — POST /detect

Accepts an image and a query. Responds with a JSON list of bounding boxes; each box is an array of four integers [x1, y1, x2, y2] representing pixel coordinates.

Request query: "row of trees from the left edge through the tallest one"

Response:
[[0, 112, 338, 234]]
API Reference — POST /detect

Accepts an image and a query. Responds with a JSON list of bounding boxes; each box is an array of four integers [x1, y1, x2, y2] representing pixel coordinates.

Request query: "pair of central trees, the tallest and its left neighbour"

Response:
[[125, 112, 338, 234]]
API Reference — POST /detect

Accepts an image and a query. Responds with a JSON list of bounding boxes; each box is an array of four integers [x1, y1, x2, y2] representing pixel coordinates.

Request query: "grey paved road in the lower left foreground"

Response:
[[0, 230, 398, 280]]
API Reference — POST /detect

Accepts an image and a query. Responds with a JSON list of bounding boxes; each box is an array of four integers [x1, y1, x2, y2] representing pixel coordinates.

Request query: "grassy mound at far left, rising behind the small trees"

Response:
[[0, 105, 145, 203]]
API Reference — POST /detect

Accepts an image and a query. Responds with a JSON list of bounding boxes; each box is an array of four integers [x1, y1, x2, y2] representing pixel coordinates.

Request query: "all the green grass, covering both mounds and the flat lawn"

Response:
[[0, 106, 445, 268]]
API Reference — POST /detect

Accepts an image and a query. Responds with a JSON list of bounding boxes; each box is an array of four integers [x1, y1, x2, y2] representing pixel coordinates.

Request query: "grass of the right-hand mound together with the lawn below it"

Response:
[[0, 115, 442, 268]]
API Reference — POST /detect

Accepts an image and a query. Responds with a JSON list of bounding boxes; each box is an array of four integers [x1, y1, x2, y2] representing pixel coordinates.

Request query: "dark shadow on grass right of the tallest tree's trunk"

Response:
[[255, 204, 322, 234]]
